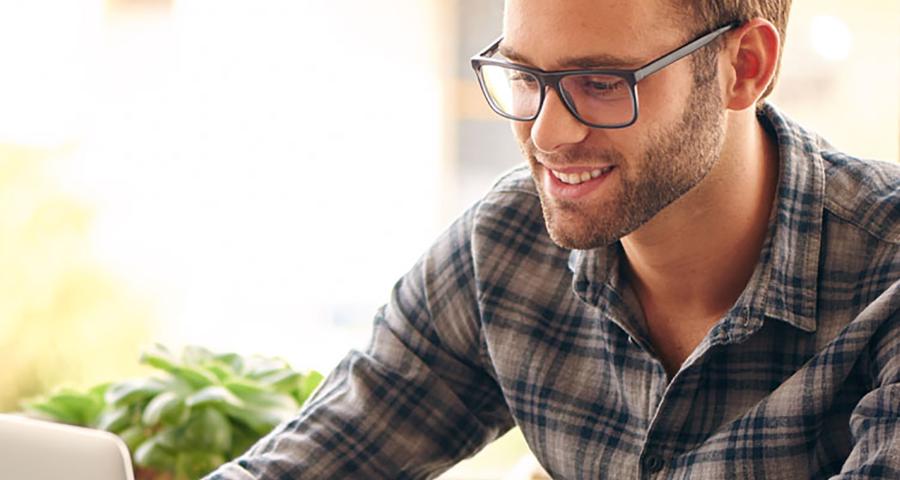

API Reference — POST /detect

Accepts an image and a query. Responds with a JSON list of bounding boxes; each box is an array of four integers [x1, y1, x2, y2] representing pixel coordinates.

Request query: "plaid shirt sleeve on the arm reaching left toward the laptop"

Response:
[[207, 205, 513, 480]]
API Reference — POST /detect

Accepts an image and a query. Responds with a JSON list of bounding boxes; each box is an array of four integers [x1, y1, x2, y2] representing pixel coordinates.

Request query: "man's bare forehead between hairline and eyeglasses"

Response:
[[501, 0, 679, 69]]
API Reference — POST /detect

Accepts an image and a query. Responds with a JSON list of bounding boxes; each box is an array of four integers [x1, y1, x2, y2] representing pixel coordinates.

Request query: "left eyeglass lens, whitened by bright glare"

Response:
[[481, 65, 541, 120]]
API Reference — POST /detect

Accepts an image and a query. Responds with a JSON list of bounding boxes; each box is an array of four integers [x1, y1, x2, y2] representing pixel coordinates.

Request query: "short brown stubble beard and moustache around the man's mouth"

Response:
[[521, 79, 725, 250]]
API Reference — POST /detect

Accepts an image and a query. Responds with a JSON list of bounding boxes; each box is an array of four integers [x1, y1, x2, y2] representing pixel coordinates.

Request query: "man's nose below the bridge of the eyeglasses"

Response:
[[531, 88, 591, 153]]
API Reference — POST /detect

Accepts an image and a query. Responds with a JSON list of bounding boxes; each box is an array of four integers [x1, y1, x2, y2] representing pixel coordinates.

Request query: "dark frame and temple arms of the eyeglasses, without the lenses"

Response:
[[471, 21, 742, 128]]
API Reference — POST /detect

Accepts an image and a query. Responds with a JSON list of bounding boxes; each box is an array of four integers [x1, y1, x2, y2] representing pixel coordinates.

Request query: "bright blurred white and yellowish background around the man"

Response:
[[0, 0, 900, 479]]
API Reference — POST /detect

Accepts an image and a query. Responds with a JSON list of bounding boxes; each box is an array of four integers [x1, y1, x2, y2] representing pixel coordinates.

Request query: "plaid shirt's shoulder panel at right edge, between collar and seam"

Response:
[[821, 148, 900, 244]]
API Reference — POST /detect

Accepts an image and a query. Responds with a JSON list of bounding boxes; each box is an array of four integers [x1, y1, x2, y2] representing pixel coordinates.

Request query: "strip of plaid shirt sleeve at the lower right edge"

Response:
[[834, 282, 900, 479]]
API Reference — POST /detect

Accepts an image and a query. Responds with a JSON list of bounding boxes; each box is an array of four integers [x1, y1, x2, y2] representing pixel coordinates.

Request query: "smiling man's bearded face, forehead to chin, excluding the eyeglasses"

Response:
[[501, 0, 724, 249]]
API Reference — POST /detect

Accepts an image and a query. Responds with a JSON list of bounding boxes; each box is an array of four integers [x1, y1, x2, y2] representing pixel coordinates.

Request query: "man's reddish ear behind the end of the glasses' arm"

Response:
[[719, 18, 781, 110]]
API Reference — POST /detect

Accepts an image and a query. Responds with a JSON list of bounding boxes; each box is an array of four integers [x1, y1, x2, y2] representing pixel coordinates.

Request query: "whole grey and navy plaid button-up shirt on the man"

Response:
[[210, 106, 900, 479]]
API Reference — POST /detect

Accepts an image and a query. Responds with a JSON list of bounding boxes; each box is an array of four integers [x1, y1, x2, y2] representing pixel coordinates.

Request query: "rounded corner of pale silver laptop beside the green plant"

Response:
[[0, 414, 134, 480]]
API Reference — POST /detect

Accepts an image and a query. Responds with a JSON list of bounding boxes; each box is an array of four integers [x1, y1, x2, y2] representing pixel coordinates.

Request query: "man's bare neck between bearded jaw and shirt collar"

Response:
[[622, 107, 778, 319]]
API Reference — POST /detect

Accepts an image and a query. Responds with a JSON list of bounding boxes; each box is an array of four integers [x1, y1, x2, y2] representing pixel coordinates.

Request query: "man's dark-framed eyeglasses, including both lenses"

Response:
[[472, 22, 740, 128]]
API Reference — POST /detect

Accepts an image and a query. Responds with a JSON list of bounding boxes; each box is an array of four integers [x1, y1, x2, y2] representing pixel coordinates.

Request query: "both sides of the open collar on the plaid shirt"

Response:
[[569, 103, 825, 335]]
